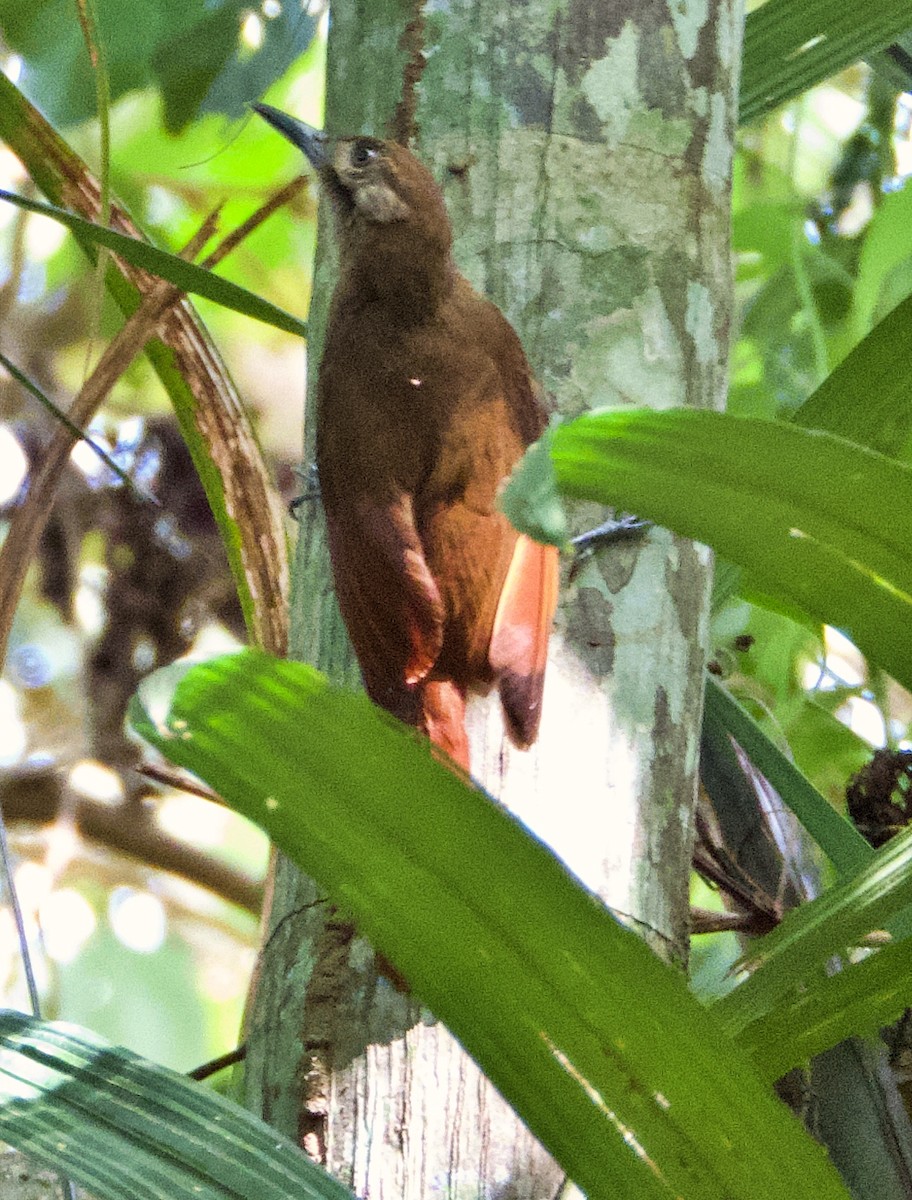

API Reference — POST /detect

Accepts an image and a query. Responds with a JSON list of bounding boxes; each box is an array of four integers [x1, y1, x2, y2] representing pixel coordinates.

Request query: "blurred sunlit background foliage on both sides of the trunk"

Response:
[[0, 0, 912, 1070]]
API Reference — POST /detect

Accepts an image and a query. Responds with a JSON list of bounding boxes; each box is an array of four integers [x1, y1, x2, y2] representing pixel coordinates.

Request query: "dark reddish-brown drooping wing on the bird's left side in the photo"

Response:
[[326, 493, 443, 700]]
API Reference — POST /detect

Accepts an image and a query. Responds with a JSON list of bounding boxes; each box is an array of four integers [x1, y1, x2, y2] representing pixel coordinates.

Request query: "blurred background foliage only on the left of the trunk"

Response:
[[0, 0, 325, 1070]]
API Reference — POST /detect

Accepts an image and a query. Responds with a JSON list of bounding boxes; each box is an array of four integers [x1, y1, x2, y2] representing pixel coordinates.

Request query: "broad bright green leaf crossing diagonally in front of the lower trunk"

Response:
[[131, 652, 845, 1200]]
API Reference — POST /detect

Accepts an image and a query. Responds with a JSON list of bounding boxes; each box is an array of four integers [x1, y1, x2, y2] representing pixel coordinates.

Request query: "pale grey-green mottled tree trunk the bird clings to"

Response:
[[247, 0, 740, 1200]]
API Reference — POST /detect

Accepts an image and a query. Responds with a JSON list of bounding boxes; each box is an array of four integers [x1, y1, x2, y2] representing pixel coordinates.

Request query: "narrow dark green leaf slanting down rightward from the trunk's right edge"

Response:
[[704, 674, 874, 875]]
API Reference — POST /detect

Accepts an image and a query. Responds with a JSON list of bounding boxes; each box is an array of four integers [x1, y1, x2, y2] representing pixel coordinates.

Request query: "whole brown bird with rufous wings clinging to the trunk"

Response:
[[254, 104, 558, 769]]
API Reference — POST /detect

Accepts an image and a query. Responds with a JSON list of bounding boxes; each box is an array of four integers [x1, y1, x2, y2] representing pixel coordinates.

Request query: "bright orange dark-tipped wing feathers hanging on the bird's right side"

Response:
[[488, 534, 559, 749]]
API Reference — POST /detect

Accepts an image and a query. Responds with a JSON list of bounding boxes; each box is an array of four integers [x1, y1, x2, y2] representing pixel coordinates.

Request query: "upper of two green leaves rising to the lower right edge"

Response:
[[713, 829, 912, 1036]]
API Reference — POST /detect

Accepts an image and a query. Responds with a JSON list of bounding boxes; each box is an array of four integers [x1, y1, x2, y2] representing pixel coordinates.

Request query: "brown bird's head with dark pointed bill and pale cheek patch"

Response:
[[253, 104, 452, 289]]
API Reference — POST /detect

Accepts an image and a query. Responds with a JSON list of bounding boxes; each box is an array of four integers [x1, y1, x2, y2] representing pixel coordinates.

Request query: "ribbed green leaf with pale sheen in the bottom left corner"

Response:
[[0, 1012, 352, 1200]]
